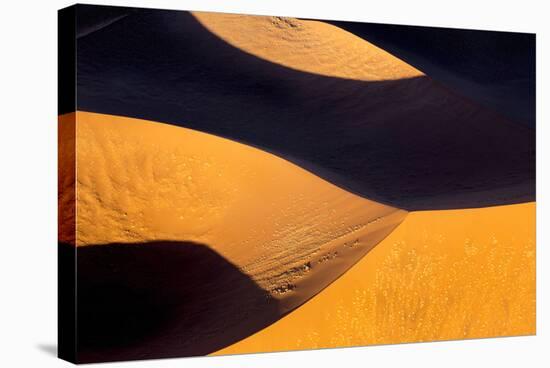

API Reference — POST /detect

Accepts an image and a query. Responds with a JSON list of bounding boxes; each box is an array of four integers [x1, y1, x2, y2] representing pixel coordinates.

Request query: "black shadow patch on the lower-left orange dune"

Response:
[[65, 241, 279, 363]]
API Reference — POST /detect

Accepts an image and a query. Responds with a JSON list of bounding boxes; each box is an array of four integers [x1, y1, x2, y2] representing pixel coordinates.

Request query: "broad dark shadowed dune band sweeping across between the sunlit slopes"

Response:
[[73, 6, 535, 210]]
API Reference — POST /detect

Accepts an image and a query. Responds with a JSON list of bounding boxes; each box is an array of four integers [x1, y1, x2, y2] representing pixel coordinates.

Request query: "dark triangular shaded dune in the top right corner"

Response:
[[330, 21, 536, 129]]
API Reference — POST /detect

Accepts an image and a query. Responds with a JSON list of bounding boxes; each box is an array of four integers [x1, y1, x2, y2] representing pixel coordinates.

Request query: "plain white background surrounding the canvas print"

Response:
[[0, 0, 550, 368]]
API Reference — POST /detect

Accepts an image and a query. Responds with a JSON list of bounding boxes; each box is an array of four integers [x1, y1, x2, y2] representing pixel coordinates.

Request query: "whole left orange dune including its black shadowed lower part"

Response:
[[60, 112, 406, 362]]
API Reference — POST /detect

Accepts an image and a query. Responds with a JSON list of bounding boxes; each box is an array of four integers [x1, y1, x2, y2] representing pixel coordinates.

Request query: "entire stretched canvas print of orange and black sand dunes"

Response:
[[58, 5, 536, 363]]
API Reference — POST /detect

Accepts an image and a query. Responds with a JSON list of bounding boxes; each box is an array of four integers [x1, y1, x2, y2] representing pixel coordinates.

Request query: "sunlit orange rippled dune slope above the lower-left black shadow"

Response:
[[61, 112, 405, 313]]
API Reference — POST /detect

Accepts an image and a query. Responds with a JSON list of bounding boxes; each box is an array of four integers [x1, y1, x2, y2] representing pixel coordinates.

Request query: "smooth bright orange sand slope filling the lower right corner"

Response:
[[218, 203, 536, 354]]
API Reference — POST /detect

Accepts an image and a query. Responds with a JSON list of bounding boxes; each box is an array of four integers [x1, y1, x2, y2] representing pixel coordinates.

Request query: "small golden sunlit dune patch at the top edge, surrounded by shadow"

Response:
[[193, 12, 424, 81]]
